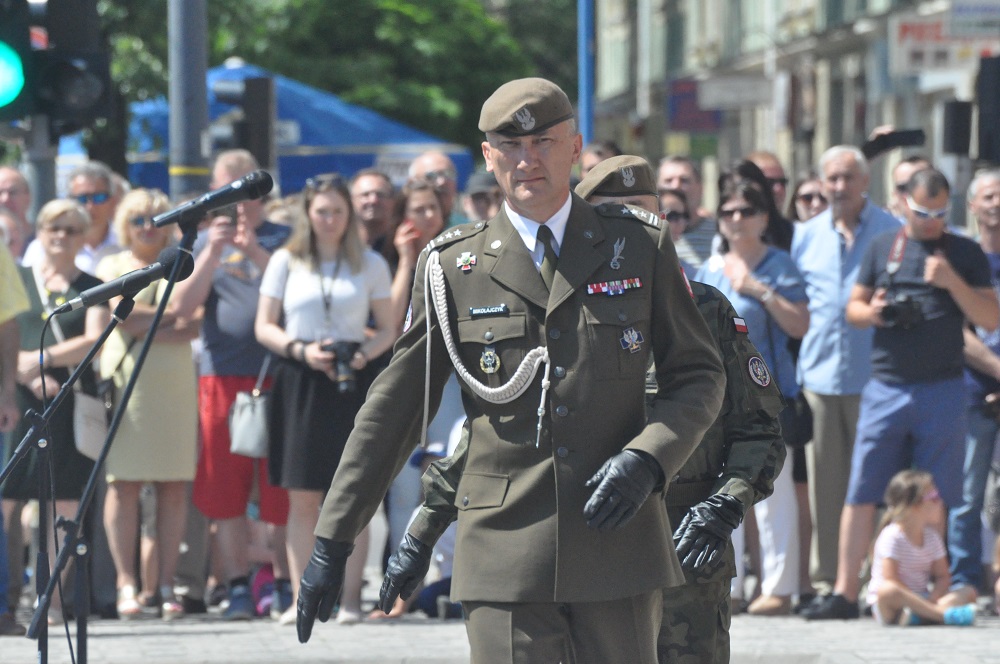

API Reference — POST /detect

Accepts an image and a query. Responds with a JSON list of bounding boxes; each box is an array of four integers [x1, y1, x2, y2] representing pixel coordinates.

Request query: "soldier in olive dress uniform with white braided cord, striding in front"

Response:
[[298, 79, 725, 664]]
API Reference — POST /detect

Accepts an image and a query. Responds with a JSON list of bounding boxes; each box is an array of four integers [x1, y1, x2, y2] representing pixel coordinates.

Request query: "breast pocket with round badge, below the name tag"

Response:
[[458, 313, 529, 387]]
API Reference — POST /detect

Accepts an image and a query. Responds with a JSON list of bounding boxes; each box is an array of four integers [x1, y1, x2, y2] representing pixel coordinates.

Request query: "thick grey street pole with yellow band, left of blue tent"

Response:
[[167, 0, 209, 200]]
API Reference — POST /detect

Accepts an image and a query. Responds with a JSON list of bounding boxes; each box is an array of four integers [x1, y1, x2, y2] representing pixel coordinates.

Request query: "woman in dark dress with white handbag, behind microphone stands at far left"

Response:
[[0, 199, 109, 623]]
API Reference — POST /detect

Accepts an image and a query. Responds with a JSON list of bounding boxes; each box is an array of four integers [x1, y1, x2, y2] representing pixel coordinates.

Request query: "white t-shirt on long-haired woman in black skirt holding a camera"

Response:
[[260, 249, 392, 342]]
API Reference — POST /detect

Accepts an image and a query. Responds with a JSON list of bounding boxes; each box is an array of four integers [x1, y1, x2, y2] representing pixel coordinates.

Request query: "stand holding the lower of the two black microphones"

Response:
[[0, 298, 135, 664]]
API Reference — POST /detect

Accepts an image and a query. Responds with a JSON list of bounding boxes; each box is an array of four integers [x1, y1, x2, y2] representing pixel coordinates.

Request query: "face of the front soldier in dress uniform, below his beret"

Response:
[[482, 121, 583, 221]]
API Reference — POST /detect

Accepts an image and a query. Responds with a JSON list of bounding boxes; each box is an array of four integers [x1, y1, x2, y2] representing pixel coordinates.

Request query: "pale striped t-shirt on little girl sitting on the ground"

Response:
[[868, 523, 947, 606]]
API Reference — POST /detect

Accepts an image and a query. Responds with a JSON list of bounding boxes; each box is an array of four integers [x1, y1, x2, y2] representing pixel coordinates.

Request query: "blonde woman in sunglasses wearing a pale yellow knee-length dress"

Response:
[[97, 189, 201, 620]]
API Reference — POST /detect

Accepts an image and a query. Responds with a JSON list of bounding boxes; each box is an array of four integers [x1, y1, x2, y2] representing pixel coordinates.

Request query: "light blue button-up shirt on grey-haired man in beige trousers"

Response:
[[792, 201, 900, 395]]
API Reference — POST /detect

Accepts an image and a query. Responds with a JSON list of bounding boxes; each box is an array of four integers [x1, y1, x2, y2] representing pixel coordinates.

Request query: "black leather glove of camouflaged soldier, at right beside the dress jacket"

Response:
[[674, 494, 743, 570]]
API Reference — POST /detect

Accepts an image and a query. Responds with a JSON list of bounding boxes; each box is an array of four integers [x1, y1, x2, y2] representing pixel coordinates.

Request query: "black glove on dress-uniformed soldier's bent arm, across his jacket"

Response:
[[583, 450, 663, 532]]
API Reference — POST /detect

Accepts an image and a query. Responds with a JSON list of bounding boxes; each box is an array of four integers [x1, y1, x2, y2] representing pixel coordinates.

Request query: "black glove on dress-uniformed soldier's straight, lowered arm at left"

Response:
[[295, 537, 354, 643]]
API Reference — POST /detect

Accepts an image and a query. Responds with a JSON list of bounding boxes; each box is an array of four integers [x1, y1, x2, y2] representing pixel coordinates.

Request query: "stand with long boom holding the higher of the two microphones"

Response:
[[15, 231, 198, 664]]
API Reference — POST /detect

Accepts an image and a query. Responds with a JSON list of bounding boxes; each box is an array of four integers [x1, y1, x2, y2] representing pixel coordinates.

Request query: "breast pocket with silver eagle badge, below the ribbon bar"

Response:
[[584, 297, 651, 380]]
